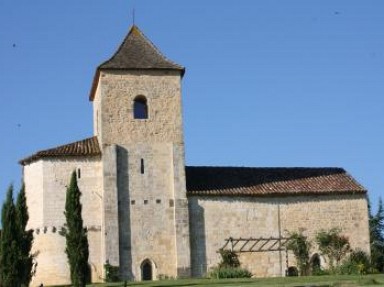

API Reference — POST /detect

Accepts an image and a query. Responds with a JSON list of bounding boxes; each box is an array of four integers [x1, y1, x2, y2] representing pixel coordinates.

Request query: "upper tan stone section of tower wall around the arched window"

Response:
[[95, 71, 183, 145]]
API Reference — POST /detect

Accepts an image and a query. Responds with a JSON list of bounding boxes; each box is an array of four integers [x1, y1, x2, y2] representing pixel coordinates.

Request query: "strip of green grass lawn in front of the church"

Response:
[[76, 274, 384, 287]]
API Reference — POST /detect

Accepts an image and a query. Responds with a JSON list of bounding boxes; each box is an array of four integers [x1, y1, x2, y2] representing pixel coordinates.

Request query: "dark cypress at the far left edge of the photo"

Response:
[[0, 185, 21, 287]]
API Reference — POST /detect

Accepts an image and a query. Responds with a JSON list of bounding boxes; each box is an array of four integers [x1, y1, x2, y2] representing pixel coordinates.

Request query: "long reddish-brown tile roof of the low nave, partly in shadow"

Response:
[[186, 166, 366, 196]]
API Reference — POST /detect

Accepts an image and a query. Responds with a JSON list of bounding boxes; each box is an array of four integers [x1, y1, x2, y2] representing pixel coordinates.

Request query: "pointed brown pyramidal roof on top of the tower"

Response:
[[89, 25, 185, 101]]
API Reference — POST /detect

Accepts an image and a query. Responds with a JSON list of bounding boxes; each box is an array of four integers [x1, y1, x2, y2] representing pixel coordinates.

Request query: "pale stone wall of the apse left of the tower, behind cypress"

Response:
[[24, 158, 103, 286]]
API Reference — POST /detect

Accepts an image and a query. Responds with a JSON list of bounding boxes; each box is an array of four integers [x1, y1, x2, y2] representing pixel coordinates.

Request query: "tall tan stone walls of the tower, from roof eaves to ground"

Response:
[[94, 71, 190, 280]]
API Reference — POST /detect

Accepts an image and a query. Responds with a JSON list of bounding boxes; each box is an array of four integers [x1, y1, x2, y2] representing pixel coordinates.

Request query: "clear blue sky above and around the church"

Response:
[[0, 0, 384, 212]]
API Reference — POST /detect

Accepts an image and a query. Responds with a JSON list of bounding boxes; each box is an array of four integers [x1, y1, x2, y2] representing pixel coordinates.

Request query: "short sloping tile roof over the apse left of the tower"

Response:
[[19, 136, 101, 165]]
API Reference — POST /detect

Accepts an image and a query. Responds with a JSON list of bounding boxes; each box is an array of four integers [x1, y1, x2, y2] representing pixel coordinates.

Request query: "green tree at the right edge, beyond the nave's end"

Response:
[[369, 198, 384, 272]]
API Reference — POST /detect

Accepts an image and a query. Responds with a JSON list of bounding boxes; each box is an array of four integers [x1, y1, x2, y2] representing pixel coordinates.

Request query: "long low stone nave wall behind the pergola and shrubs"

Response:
[[189, 194, 369, 276]]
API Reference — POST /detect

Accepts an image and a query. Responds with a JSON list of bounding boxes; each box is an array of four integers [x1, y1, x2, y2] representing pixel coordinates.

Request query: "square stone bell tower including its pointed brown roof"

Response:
[[90, 26, 190, 280]]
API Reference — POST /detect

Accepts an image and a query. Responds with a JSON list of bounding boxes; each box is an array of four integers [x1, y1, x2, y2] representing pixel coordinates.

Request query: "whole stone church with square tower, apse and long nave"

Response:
[[20, 26, 370, 286]]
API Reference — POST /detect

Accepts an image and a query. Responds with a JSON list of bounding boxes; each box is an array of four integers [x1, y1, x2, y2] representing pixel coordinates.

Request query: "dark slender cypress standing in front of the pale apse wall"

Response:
[[64, 171, 89, 287]]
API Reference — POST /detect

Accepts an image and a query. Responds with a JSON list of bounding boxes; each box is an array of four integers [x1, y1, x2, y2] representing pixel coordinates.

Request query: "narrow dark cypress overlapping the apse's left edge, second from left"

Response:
[[16, 184, 34, 286]]
